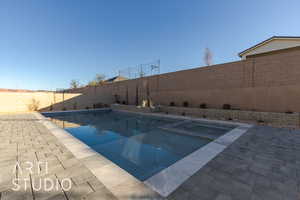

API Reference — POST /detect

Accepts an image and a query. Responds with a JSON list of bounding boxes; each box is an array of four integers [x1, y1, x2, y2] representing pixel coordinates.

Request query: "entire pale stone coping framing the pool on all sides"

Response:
[[35, 108, 253, 197]]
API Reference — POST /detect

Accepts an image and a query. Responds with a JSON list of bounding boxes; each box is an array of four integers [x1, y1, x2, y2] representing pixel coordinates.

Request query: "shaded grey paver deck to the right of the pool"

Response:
[[168, 126, 300, 200]]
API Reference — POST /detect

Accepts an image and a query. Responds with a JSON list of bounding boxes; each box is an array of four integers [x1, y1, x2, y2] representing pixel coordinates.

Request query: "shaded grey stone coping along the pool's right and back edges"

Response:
[[110, 109, 253, 197]]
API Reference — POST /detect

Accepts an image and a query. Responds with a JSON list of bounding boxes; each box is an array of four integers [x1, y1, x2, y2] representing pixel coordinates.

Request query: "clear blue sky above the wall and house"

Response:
[[0, 0, 300, 90]]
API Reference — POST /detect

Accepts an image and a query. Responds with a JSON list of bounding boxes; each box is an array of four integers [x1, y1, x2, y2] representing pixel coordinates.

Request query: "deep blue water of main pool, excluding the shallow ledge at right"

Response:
[[44, 111, 230, 181]]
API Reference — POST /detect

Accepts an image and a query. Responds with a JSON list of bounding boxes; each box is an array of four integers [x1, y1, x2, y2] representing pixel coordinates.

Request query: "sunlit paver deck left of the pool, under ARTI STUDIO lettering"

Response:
[[0, 114, 117, 200]]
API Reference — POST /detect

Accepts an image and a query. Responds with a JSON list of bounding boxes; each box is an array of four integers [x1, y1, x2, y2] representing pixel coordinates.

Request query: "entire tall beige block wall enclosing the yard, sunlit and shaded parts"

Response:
[[0, 48, 300, 112]]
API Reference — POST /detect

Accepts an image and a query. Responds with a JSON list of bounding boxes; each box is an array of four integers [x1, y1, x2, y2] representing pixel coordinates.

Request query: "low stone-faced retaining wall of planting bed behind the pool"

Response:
[[111, 104, 300, 128]]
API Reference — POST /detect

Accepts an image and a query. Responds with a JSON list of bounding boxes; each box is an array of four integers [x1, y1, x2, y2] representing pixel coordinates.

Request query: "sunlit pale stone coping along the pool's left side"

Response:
[[33, 108, 162, 199]]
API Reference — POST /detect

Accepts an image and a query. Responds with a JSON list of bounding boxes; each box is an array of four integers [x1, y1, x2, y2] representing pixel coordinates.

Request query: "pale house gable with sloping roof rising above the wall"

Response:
[[238, 36, 300, 60]]
